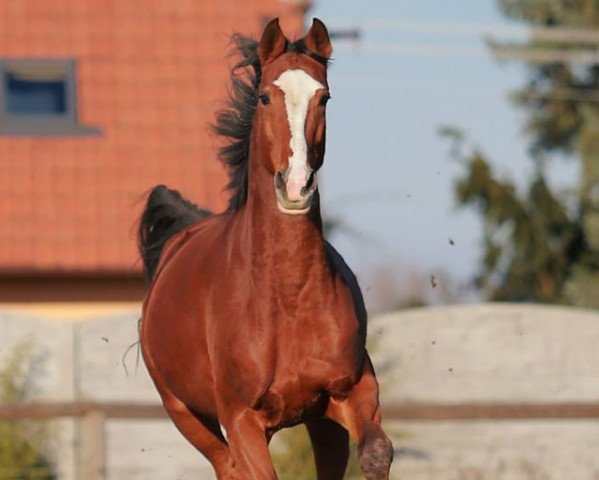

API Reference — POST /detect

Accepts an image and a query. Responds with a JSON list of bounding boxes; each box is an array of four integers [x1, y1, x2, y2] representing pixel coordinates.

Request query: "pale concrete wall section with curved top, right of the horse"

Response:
[[370, 304, 599, 480]]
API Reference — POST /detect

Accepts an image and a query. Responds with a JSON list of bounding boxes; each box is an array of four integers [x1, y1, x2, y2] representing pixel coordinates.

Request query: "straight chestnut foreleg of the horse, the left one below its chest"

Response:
[[223, 408, 277, 480]]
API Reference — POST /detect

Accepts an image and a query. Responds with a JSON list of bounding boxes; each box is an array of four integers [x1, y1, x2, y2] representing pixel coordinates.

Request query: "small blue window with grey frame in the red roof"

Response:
[[0, 59, 100, 135]]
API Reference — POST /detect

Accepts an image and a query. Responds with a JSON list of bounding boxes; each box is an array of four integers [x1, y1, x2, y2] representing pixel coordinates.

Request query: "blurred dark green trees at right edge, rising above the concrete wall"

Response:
[[443, 0, 599, 308]]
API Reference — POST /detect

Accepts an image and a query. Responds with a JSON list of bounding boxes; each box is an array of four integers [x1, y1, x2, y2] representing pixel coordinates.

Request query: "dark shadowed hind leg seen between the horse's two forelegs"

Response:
[[306, 418, 349, 480]]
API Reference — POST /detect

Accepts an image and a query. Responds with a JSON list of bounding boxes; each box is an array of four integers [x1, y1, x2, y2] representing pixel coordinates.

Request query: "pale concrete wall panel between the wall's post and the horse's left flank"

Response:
[[77, 312, 213, 480]]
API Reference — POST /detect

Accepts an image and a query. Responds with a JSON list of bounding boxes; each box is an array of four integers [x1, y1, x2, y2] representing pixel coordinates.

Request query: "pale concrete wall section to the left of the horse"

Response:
[[0, 310, 213, 480]]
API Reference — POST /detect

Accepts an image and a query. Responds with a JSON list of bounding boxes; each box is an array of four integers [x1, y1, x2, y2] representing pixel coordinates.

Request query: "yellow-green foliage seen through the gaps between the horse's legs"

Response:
[[272, 425, 362, 480]]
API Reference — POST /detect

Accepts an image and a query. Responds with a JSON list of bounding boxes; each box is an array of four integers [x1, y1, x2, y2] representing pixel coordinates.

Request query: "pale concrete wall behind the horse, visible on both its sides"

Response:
[[0, 304, 599, 480]]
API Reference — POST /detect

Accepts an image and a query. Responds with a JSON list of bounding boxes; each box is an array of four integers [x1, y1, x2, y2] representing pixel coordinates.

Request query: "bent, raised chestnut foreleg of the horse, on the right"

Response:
[[326, 355, 393, 480]]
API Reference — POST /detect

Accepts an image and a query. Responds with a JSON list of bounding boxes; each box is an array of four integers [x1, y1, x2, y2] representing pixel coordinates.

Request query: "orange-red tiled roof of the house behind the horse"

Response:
[[0, 0, 303, 275]]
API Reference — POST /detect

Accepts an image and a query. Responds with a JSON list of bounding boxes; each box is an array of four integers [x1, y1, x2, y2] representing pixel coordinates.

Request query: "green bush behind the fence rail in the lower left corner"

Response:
[[0, 343, 56, 480]]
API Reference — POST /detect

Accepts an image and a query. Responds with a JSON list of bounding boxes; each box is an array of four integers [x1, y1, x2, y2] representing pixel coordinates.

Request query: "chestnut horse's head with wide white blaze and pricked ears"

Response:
[[254, 19, 332, 215]]
